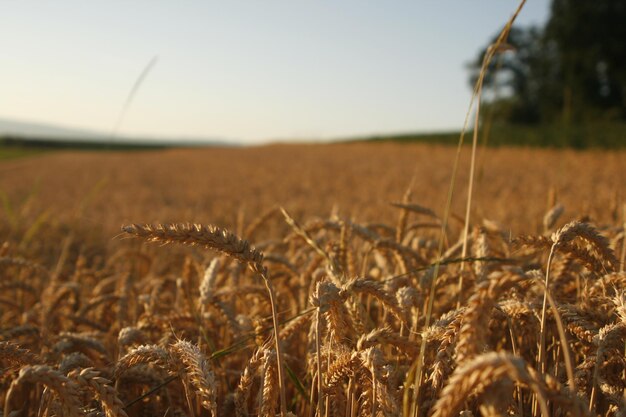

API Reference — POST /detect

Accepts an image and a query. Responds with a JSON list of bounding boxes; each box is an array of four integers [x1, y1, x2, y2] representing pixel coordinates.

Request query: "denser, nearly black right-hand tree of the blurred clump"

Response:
[[544, 0, 626, 122]]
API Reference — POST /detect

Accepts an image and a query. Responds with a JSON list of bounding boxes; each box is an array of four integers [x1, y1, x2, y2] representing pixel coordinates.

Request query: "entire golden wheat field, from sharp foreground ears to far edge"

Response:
[[0, 143, 626, 417]]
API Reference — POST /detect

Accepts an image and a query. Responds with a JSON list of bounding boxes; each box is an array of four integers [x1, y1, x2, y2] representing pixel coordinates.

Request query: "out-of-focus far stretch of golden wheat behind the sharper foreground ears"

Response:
[[0, 142, 626, 260]]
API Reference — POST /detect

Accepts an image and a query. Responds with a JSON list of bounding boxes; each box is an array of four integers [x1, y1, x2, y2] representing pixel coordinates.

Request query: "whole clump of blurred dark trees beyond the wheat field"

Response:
[[469, 0, 626, 145]]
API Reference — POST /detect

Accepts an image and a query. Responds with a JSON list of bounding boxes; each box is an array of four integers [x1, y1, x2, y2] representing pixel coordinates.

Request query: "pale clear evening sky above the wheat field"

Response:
[[0, 0, 549, 143]]
